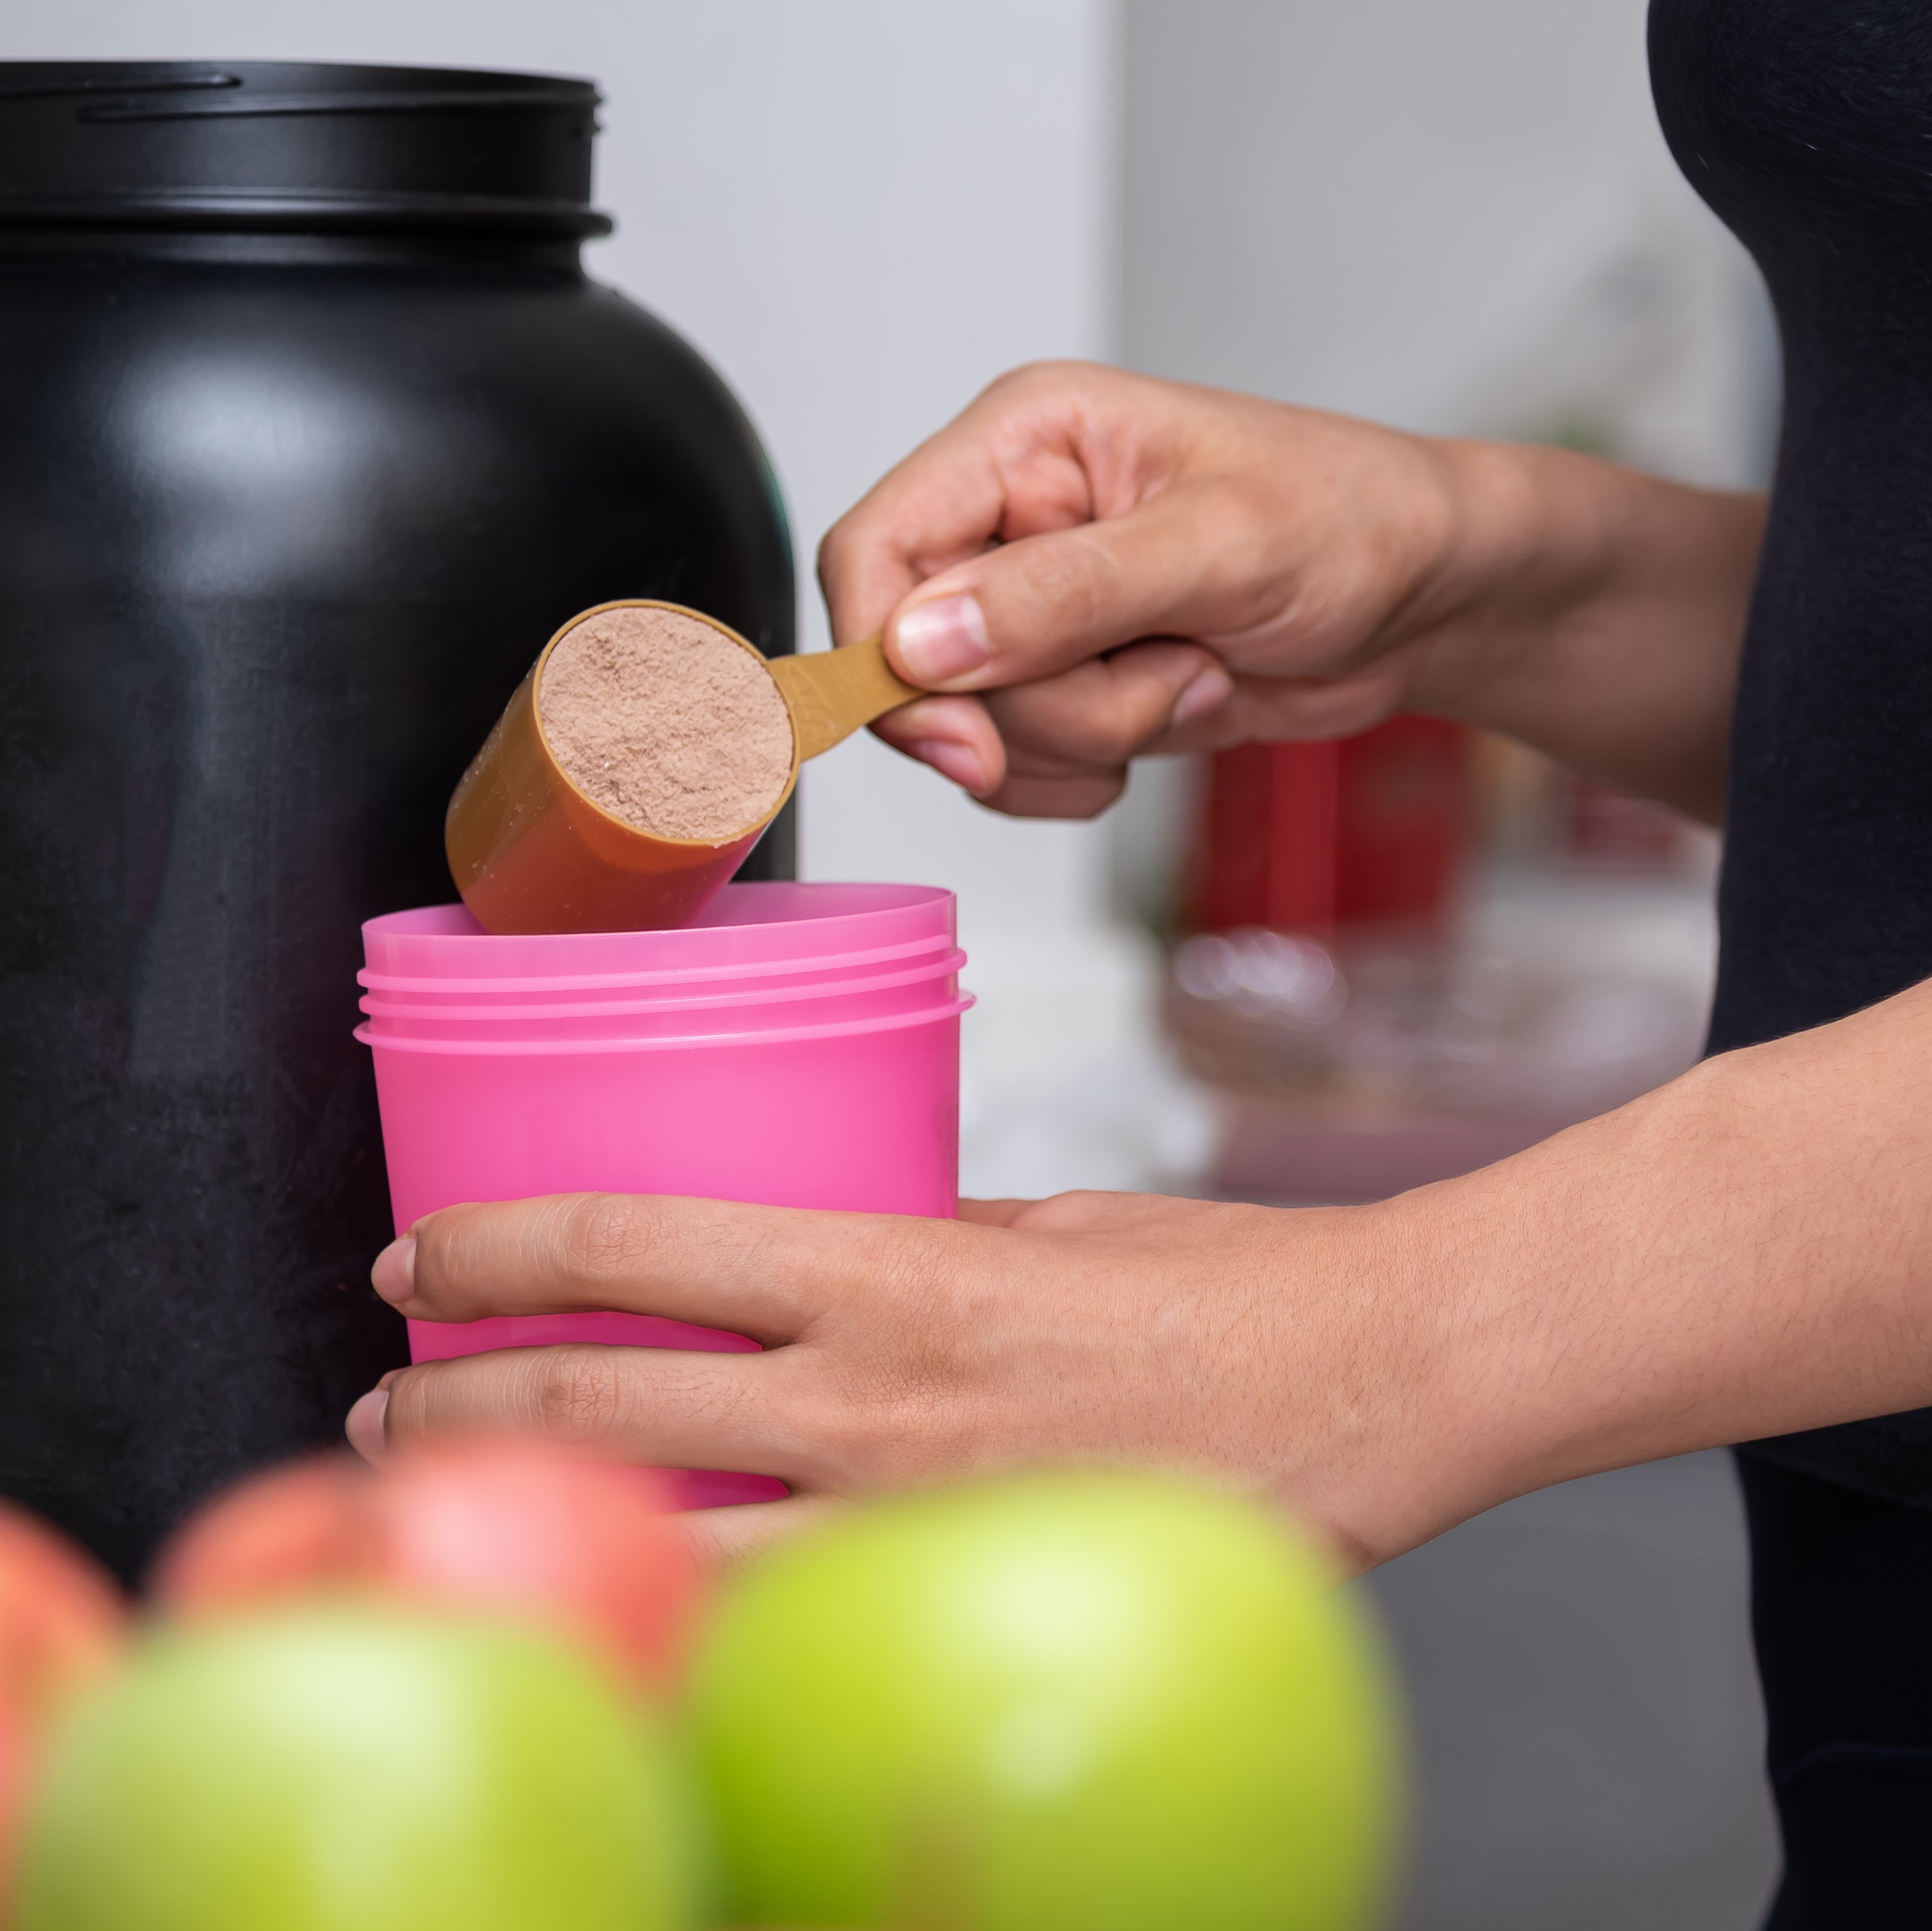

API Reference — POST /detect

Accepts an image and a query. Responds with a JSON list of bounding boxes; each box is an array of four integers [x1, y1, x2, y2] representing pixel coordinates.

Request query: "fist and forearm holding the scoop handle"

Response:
[[819, 363, 1764, 823]]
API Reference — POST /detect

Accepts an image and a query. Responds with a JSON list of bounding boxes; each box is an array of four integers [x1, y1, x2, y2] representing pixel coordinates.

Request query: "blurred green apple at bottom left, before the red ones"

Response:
[[12, 1605, 691, 1931]]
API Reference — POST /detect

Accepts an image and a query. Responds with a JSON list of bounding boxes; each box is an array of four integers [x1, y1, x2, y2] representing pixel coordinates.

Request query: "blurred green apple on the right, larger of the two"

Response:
[[694, 1474, 1399, 1931]]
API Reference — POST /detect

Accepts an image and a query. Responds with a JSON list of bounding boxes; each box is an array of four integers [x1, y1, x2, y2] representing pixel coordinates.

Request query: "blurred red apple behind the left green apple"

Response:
[[154, 1437, 700, 1690]]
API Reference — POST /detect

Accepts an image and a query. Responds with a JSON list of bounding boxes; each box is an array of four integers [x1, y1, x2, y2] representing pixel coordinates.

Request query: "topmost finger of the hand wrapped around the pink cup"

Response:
[[371, 1194, 929, 1348]]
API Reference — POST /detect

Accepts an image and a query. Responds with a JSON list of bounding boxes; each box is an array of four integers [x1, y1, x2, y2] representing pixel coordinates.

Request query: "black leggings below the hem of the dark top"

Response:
[[1737, 1452, 1932, 1931]]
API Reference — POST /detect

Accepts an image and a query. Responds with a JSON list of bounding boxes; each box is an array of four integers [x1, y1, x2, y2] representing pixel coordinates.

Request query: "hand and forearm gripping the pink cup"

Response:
[[350, 987, 1932, 1564]]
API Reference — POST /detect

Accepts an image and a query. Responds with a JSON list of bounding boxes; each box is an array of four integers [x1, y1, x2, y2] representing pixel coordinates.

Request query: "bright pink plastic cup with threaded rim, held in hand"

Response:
[[356, 884, 972, 1508]]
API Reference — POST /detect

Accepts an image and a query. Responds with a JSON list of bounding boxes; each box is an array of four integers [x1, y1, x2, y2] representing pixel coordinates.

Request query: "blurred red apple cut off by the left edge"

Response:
[[0, 1502, 127, 1885]]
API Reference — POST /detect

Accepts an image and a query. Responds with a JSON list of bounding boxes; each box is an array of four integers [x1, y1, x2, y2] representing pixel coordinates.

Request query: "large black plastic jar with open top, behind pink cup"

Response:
[[0, 62, 794, 1578]]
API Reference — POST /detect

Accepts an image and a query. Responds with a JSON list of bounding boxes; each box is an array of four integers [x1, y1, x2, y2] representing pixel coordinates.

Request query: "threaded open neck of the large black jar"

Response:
[[0, 60, 611, 236]]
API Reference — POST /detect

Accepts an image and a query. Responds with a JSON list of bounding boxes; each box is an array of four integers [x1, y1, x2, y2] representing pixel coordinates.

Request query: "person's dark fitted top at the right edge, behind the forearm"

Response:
[[1650, 0, 1932, 1506]]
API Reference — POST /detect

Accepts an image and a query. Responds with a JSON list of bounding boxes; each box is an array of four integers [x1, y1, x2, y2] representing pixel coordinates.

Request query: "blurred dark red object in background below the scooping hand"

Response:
[[1190, 717, 1470, 933]]
